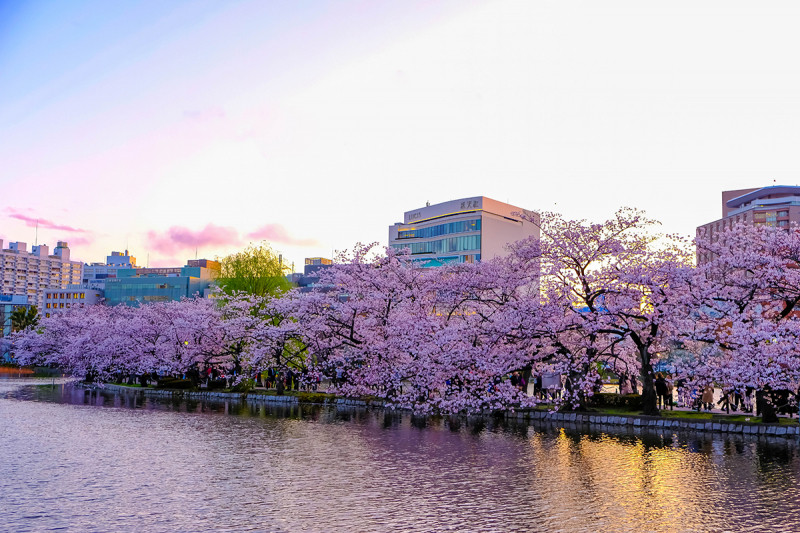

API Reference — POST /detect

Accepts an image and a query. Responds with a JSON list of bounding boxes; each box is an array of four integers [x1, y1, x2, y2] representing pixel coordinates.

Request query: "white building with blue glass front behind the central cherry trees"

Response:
[[389, 196, 539, 267]]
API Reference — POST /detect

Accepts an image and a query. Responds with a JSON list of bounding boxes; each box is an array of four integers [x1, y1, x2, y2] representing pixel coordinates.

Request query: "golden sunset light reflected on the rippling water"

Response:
[[529, 428, 746, 531]]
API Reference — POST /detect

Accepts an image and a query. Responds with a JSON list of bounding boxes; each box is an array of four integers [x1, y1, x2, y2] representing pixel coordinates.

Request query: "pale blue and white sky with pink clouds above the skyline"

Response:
[[0, 0, 800, 270]]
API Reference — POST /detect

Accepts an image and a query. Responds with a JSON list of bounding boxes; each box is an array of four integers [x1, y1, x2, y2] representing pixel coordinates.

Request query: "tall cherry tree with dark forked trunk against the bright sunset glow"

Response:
[[512, 208, 689, 414]]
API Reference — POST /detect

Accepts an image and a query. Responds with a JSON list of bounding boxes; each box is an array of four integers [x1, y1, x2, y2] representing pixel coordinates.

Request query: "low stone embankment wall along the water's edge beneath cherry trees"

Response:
[[94, 384, 800, 437]]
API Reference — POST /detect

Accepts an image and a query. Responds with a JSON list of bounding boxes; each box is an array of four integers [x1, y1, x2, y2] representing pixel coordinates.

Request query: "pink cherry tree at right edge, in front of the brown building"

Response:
[[679, 224, 800, 420]]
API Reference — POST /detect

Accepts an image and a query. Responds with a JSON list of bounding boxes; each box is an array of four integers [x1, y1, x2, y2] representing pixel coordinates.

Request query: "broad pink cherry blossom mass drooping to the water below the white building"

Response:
[[288, 245, 535, 412]]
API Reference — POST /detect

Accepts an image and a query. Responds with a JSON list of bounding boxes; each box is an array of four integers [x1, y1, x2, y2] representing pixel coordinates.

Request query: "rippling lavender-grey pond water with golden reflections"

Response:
[[0, 379, 800, 533]]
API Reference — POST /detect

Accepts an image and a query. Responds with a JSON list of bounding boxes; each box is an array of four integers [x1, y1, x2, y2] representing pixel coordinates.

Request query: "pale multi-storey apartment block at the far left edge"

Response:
[[0, 239, 83, 311]]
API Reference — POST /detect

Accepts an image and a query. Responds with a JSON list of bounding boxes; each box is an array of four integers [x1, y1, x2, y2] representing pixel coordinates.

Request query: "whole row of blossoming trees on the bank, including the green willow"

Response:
[[12, 209, 800, 416]]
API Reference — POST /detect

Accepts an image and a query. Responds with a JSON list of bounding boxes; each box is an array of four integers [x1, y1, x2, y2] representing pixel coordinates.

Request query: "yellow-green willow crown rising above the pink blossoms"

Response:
[[217, 242, 292, 296]]
